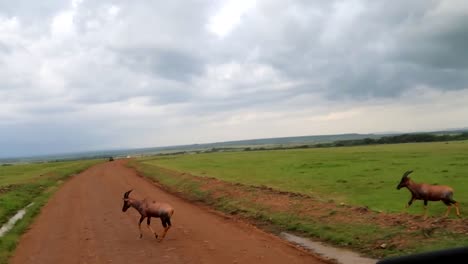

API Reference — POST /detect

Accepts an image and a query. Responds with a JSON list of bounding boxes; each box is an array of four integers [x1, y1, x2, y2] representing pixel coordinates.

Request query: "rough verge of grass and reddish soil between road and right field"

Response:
[[130, 160, 468, 258]]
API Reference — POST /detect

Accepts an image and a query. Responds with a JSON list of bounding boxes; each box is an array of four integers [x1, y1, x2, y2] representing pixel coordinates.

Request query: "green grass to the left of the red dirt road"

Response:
[[0, 160, 102, 263]]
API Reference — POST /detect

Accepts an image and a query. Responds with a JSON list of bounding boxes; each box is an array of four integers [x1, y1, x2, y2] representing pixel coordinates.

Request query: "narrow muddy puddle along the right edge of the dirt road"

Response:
[[280, 232, 378, 264]]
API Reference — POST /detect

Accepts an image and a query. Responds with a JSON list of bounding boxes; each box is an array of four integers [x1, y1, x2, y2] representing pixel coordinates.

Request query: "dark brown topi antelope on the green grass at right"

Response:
[[397, 171, 460, 219]]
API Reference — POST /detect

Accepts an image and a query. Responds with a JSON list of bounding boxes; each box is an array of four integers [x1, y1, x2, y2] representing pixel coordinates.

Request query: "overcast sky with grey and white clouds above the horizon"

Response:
[[0, 0, 468, 157]]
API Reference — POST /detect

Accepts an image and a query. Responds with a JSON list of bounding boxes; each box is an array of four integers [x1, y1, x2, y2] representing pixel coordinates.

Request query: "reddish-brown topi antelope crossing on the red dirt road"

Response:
[[122, 190, 174, 242]]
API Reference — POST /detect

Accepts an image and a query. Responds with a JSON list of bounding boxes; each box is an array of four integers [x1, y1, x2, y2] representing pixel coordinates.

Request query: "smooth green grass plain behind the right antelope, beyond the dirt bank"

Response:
[[140, 141, 468, 216]]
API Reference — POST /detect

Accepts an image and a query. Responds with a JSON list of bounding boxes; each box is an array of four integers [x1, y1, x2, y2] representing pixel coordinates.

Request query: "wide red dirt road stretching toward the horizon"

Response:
[[10, 160, 327, 264]]
